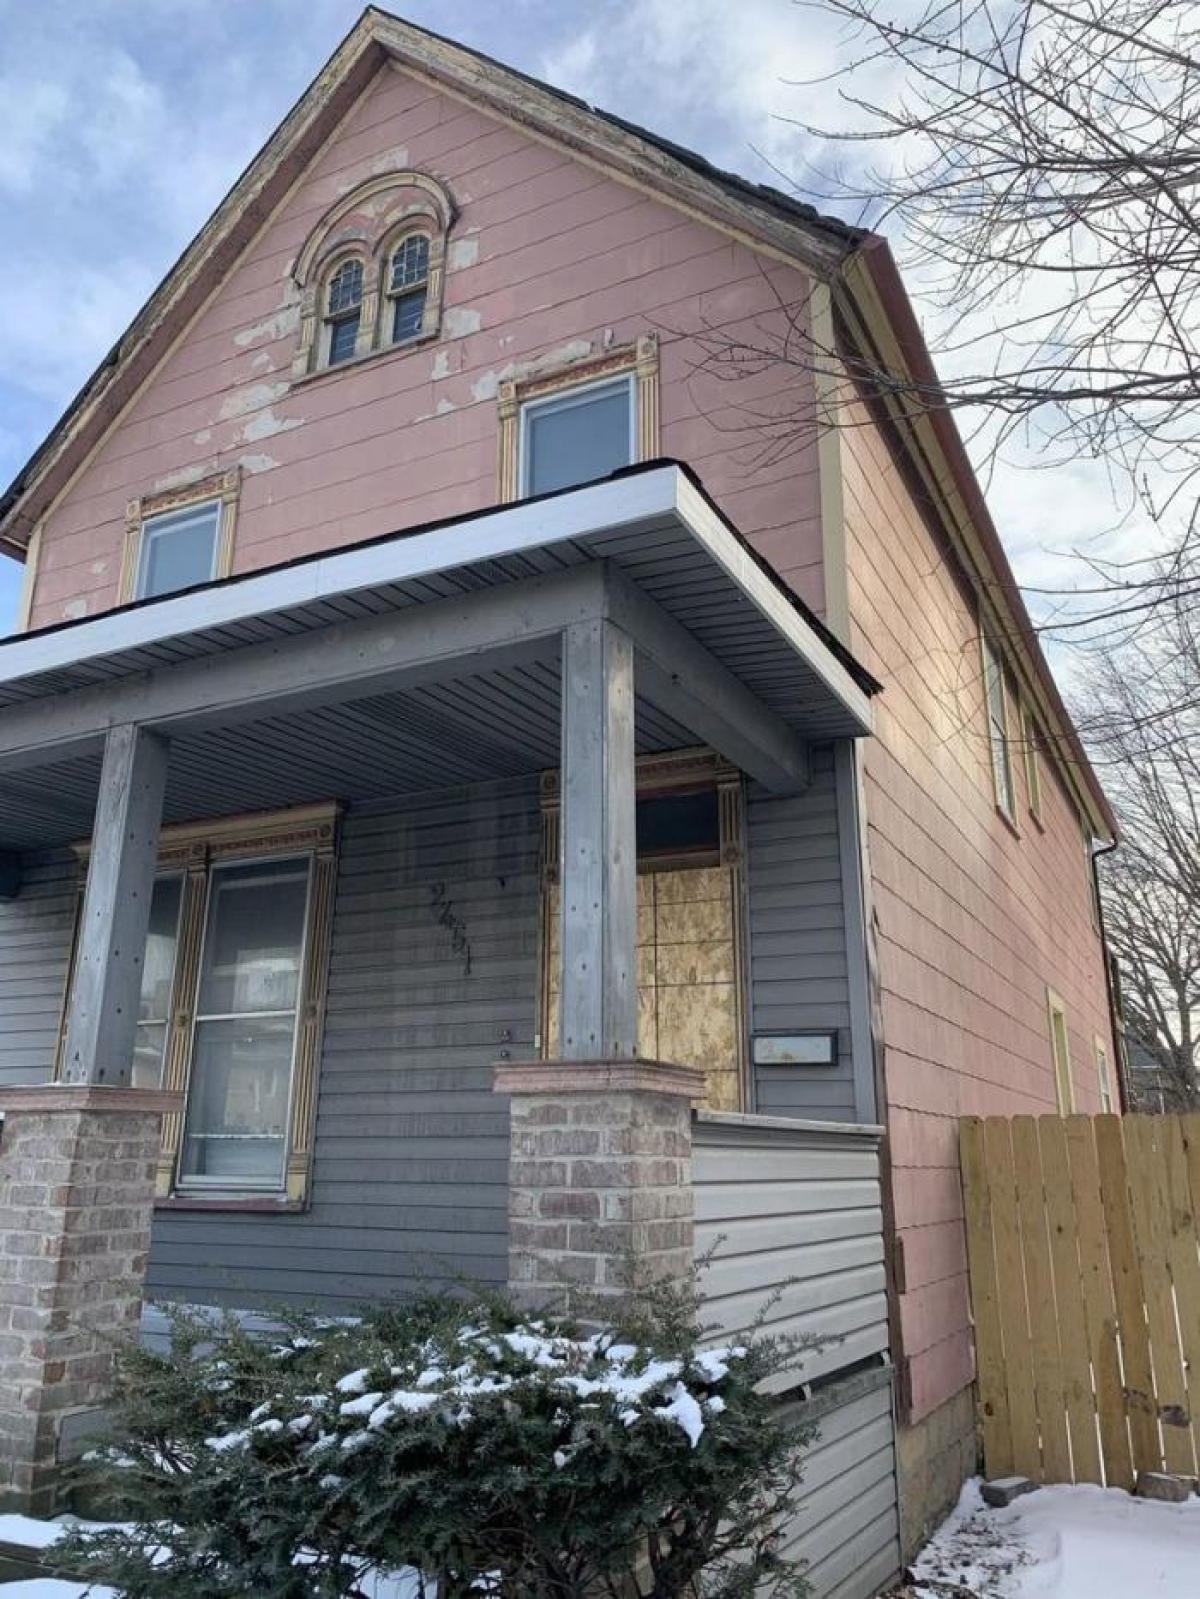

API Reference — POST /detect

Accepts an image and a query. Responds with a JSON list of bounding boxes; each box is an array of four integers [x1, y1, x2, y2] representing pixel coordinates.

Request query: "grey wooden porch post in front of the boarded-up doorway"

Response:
[[562, 619, 637, 1062]]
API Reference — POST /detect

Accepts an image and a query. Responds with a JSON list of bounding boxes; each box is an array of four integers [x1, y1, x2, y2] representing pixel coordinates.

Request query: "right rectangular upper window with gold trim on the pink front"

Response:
[[498, 334, 659, 500]]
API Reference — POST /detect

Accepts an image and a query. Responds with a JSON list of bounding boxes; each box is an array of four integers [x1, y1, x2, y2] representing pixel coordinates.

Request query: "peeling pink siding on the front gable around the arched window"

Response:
[[32, 67, 822, 627]]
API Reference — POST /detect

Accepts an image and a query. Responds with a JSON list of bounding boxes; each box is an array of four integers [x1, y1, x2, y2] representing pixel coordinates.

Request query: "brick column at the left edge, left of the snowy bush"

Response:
[[0, 1084, 179, 1514]]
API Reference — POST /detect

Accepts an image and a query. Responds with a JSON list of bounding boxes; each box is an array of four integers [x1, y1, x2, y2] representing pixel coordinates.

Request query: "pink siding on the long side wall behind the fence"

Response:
[[843, 396, 1114, 1420]]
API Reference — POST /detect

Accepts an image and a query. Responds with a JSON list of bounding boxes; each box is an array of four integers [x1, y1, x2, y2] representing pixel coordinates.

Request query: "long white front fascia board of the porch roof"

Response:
[[0, 467, 682, 683]]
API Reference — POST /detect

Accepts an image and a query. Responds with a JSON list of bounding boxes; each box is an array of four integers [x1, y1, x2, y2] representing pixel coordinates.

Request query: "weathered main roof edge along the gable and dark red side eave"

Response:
[[0, 6, 1115, 836]]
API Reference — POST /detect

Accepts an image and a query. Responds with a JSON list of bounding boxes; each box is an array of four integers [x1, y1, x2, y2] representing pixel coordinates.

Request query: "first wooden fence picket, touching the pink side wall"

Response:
[[958, 1116, 1013, 1477]]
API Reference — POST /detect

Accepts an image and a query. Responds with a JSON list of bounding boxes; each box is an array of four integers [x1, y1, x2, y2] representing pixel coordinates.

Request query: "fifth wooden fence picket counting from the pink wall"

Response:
[[1068, 1116, 1133, 1489]]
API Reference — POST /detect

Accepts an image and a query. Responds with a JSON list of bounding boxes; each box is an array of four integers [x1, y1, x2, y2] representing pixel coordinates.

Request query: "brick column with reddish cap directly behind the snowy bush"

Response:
[[494, 1060, 704, 1305]]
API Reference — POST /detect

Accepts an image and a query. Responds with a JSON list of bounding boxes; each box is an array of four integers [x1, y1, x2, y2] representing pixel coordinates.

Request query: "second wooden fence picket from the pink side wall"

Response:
[[984, 1116, 1042, 1482]]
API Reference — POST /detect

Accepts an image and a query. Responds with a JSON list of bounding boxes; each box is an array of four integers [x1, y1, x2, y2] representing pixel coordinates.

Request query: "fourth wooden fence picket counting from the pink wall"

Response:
[[1037, 1116, 1107, 1482]]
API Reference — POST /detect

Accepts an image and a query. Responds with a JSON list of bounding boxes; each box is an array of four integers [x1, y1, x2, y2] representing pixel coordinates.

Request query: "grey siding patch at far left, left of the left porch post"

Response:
[[0, 849, 78, 1084]]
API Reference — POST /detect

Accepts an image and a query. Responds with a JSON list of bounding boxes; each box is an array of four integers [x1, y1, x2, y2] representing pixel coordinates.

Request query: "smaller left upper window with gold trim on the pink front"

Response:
[[117, 467, 240, 604]]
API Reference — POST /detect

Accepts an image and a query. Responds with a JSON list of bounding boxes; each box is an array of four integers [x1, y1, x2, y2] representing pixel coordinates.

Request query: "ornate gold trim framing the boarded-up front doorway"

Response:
[[538, 748, 752, 1110]]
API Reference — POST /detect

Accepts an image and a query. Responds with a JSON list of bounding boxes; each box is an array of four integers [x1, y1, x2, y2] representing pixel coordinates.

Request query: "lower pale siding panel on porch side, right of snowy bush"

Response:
[[784, 1370, 901, 1599]]
